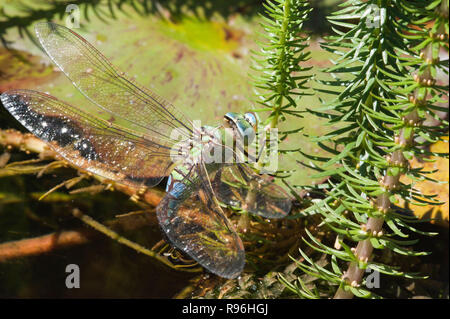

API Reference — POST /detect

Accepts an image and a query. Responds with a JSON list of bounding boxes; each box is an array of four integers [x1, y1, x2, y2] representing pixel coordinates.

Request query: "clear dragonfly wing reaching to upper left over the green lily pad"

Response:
[[35, 22, 192, 144]]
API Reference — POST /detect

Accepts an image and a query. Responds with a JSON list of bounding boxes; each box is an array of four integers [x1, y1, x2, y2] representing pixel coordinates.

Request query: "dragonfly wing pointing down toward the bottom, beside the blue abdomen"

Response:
[[157, 168, 245, 278]]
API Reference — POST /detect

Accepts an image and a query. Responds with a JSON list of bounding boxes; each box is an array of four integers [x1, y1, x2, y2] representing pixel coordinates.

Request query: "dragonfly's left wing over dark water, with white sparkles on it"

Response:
[[1, 90, 172, 187]]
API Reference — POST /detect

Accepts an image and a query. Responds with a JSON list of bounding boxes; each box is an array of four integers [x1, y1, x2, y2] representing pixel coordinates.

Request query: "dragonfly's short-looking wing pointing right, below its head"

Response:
[[212, 164, 292, 218]]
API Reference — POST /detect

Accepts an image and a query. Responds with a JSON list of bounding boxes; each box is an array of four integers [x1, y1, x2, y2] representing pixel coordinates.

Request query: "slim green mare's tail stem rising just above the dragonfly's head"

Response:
[[250, 0, 312, 177]]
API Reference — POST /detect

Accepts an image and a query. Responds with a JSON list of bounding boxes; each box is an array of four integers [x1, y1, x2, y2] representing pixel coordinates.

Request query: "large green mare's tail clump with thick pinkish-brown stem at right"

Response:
[[280, 0, 449, 298]]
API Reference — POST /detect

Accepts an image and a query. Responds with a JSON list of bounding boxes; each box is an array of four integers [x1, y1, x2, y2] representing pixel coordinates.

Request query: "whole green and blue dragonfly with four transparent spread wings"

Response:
[[0, 22, 291, 278]]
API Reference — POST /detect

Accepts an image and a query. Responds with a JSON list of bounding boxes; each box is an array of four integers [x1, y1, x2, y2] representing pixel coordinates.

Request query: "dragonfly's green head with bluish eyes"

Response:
[[224, 112, 258, 144]]
